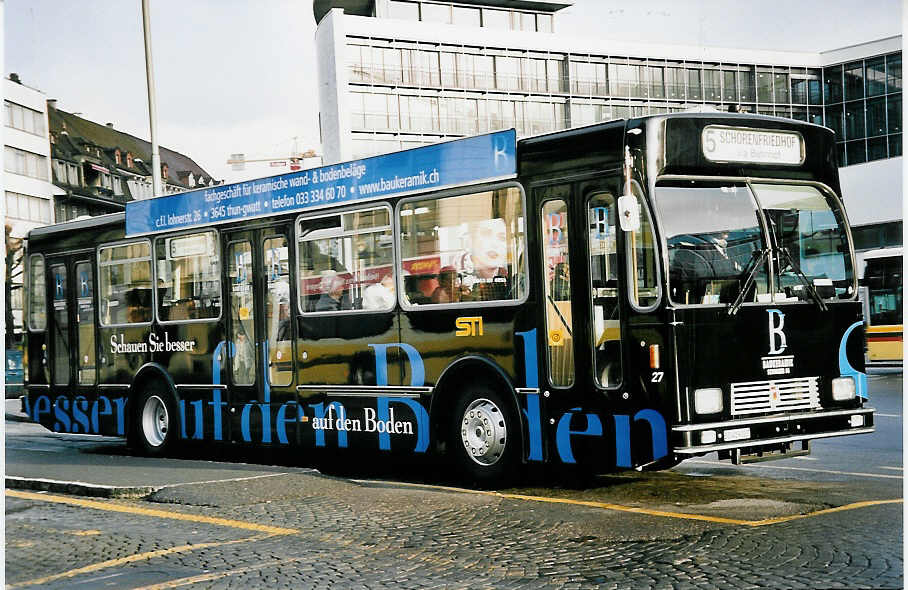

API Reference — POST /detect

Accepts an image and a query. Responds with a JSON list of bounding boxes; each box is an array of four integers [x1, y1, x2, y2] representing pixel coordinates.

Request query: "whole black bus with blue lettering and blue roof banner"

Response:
[[24, 113, 873, 482]]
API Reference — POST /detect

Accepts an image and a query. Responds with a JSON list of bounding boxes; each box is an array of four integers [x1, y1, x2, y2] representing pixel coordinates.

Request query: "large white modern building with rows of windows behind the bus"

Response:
[[314, 0, 902, 249]]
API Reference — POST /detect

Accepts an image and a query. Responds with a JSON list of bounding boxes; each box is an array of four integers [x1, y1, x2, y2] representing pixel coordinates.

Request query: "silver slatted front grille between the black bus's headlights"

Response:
[[731, 377, 820, 416]]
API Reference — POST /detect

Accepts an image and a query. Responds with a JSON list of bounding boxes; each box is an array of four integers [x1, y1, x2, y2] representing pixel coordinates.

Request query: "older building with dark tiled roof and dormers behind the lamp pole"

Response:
[[47, 100, 219, 222]]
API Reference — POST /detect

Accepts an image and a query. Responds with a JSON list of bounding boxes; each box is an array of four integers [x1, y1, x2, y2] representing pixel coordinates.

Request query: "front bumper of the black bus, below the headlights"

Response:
[[672, 408, 874, 457]]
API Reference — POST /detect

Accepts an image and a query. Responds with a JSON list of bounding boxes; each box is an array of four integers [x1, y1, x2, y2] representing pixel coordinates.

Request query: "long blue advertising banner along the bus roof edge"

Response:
[[126, 129, 517, 236]]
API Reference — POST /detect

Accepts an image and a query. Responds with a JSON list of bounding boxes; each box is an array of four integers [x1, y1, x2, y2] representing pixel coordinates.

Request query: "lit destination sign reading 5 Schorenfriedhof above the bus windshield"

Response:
[[701, 125, 804, 165]]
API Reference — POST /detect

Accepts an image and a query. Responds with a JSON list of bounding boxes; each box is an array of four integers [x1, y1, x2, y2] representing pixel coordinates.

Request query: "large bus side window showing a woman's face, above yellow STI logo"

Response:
[[399, 187, 526, 306]]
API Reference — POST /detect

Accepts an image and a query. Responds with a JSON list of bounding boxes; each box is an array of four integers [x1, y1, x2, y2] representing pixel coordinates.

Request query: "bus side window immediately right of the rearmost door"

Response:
[[98, 241, 152, 326]]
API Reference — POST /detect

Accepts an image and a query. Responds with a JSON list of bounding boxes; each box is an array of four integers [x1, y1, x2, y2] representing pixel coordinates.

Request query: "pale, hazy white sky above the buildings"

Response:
[[0, 0, 902, 182]]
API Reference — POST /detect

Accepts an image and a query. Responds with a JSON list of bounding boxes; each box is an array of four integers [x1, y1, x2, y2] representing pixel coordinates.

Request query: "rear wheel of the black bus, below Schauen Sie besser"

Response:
[[131, 382, 179, 457]]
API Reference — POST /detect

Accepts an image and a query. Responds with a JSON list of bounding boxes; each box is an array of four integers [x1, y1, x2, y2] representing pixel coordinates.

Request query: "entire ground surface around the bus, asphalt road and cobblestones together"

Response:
[[6, 374, 904, 589]]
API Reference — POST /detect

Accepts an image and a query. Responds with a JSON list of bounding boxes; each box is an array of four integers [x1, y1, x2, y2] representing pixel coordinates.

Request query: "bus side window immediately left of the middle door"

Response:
[[155, 231, 221, 322]]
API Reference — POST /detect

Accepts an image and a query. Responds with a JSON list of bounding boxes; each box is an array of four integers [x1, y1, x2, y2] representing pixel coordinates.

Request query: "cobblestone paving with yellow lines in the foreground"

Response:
[[6, 474, 903, 589]]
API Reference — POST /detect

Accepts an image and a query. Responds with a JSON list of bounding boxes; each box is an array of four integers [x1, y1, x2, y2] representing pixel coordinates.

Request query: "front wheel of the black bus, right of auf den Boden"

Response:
[[446, 383, 520, 486]]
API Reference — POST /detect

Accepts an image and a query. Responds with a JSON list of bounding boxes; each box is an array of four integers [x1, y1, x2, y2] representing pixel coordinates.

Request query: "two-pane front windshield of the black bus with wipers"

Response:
[[655, 180, 854, 305]]
